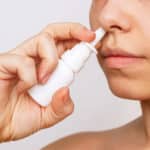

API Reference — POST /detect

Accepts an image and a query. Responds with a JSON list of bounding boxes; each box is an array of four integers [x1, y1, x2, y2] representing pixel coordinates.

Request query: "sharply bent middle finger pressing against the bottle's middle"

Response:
[[13, 33, 58, 83]]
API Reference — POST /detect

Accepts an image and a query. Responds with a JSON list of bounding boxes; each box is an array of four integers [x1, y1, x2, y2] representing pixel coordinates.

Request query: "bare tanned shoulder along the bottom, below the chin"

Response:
[[42, 119, 142, 150]]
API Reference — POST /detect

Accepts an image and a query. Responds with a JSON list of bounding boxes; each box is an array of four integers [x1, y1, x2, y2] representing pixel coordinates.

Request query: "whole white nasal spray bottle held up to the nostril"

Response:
[[29, 29, 105, 106]]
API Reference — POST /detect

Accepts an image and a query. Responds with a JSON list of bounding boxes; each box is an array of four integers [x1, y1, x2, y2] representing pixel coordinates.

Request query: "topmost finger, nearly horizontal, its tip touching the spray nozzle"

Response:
[[43, 23, 95, 42]]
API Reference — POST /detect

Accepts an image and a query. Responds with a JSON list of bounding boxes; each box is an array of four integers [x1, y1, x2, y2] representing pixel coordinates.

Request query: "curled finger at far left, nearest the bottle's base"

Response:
[[0, 54, 37, 92]]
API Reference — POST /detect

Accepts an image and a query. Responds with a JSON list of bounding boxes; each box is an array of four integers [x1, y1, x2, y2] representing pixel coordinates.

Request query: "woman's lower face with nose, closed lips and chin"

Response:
[[90, 0, 150, 100]]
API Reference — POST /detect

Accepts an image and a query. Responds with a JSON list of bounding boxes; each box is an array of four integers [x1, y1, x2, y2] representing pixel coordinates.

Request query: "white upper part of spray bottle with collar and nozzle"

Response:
[[61, 29, 105, 73]]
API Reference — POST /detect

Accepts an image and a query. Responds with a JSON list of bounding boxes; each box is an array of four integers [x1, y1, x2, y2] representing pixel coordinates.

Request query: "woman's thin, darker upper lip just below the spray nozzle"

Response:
[[100, 48, 143, 58]]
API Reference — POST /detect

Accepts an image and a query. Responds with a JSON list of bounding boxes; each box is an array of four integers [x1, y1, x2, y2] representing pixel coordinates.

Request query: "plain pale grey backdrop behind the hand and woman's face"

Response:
[[0, 0, 141, 150]]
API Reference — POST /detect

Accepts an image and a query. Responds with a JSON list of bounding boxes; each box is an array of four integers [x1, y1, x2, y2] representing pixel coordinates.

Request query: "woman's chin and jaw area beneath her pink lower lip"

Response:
[[104, 63, 150, 100]]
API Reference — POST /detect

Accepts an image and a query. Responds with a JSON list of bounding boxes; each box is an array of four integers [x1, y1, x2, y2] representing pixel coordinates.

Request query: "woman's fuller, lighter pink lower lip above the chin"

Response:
[[104, 56, 143, 69]]
